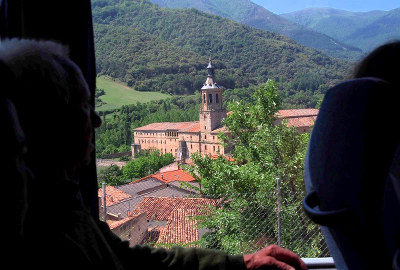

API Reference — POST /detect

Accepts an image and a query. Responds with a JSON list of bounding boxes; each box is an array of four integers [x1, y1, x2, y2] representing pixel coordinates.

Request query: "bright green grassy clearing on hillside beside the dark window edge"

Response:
[[96, 76, 171, 111]]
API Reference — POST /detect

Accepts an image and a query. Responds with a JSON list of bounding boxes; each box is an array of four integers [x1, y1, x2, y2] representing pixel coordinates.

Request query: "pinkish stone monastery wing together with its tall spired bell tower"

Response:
[[132, 56, 226, 160]]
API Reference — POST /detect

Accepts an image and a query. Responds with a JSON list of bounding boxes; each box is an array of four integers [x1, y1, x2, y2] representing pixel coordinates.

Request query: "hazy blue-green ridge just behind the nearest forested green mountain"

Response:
[[151, 0, 360, 59]]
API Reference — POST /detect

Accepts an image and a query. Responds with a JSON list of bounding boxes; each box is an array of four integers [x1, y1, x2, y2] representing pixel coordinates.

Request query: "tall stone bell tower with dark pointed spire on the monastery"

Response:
[[199, 51, 226, 135]]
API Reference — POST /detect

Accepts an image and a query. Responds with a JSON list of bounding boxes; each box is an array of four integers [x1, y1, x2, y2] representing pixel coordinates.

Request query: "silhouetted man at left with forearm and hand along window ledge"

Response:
[[0, 39, 306, 270]]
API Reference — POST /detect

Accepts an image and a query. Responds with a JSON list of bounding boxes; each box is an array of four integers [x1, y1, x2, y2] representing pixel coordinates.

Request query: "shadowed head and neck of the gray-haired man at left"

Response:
[[0, 39, 101, 177]]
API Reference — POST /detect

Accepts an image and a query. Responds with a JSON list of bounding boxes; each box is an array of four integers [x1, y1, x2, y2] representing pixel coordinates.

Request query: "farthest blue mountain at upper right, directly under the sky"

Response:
[[281, 8, 400, 51]]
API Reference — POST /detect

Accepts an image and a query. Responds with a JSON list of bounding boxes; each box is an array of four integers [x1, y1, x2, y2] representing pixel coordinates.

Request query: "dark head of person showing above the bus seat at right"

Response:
[[353, 41, 400, 85]]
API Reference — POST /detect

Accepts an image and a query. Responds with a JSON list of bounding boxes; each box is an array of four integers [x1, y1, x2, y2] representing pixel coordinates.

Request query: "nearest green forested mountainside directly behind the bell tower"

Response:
[[92, 0, 350, 101]]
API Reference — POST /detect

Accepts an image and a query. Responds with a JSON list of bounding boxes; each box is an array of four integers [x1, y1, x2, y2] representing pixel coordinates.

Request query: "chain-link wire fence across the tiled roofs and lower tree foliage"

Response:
[[99, 179, 330, 257]]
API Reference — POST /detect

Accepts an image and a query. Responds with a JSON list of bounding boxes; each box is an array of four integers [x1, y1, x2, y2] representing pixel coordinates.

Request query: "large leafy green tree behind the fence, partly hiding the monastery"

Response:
[[188, 80, 323, 256]]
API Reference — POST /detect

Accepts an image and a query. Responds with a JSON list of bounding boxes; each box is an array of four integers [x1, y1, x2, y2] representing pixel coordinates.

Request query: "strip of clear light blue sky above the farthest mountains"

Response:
[[251, 0, 400, 14]]
